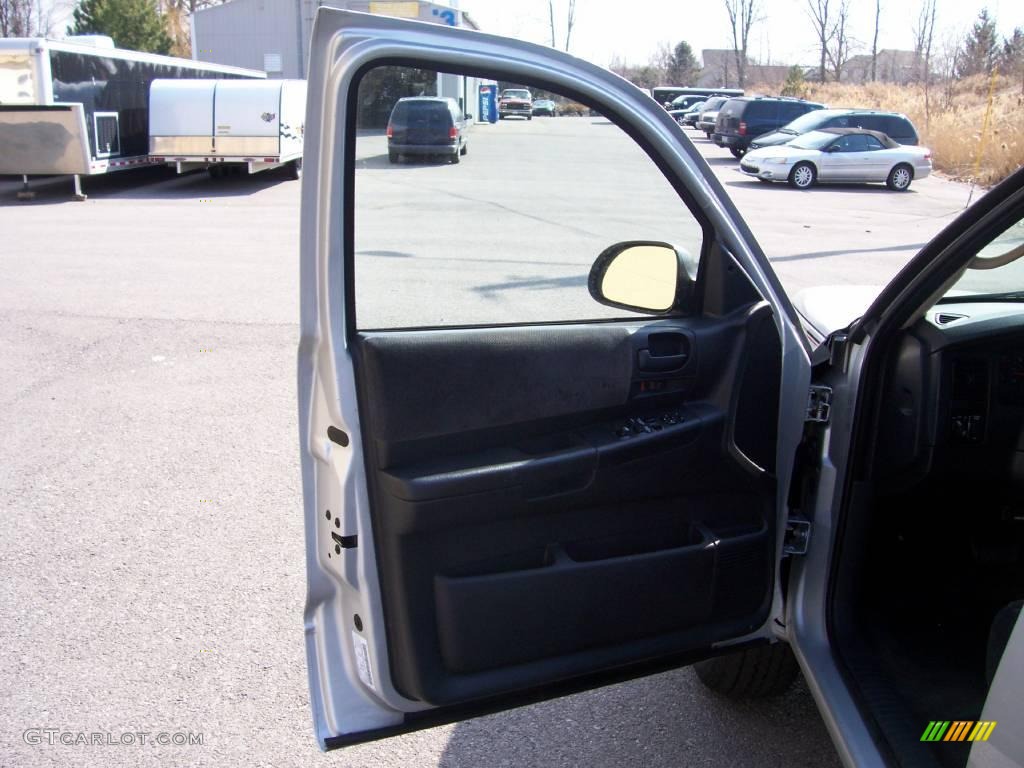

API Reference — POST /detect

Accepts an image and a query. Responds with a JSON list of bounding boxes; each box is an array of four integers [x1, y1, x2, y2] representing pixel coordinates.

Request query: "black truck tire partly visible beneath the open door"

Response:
[[693, 643, 800, 699]]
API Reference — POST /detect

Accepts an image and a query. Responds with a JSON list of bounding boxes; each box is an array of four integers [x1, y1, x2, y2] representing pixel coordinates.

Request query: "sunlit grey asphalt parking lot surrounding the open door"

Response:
[[0, 118, 983, 767]]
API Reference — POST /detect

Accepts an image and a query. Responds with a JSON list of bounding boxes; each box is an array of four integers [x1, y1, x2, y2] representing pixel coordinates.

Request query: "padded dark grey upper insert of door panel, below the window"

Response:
[[360, 326, 633, 441]]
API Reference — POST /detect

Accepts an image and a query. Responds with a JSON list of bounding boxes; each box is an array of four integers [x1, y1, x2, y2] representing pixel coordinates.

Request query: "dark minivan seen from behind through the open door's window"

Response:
[[387, 96, 468, 163]]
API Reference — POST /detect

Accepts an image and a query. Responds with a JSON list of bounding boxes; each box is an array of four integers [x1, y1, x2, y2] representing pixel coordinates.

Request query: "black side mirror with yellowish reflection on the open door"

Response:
[[587, 241, 695, 314]]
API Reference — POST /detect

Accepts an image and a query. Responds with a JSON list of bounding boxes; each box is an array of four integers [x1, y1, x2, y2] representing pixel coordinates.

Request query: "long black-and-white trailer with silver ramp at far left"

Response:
[[0, 37, 266, 198]]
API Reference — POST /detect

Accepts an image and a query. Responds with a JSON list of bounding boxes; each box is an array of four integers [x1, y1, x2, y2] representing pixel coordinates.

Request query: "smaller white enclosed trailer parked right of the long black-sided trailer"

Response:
[[150, 80, 306, 178]]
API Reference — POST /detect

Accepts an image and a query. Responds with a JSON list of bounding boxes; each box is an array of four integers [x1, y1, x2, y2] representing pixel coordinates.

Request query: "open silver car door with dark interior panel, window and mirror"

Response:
[[298, 8, 810, 749]]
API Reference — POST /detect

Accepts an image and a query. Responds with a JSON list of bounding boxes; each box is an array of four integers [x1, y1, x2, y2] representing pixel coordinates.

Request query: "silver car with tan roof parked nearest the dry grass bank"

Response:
[[739, 128, 932, 191]]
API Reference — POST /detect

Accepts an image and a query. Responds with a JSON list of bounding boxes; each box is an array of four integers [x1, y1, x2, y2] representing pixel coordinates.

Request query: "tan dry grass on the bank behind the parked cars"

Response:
[[752, 77, 1024, 184]]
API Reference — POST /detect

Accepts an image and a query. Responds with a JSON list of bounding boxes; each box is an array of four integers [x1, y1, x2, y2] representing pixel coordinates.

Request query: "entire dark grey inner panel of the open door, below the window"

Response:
[[354, 305, 779, 705]]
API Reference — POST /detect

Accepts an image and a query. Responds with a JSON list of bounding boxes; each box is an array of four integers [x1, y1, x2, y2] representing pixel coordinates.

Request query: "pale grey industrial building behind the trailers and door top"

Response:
[[191, 0, 483, 114]]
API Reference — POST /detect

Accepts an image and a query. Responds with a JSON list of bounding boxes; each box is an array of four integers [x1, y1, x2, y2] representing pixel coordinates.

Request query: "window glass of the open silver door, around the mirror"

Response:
[[353, 68, 702, 329]]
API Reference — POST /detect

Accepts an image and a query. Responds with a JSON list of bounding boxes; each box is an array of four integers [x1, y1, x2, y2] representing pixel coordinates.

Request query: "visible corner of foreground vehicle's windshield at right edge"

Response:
[[939, 219, 1024, 304]]
